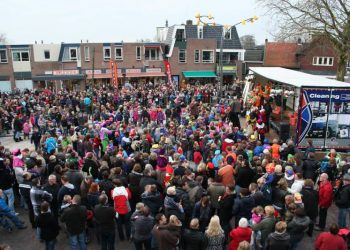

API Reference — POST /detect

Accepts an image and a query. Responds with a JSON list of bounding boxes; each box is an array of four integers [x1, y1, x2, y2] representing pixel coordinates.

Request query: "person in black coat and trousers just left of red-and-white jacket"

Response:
[[94, 194, 115, 249]]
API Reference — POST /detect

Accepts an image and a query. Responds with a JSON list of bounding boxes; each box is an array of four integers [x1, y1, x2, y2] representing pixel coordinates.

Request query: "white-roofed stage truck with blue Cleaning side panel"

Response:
[[243, 67, 350, 151]]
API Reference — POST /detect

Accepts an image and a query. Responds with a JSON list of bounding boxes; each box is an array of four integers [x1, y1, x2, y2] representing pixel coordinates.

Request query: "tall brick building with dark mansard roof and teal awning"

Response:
[[157, 20, 245, 83]]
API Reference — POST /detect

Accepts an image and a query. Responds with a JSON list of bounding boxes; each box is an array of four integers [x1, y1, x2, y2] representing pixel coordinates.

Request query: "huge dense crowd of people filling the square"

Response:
[[0, 80, 350, 250]]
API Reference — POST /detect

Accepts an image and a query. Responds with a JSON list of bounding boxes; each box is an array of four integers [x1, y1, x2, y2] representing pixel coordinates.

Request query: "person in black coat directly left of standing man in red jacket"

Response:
[[300, 179, 318, 237]]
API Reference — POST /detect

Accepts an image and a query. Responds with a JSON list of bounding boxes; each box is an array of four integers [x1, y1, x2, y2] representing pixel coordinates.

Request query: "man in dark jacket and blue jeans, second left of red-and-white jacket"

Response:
[[61, 195, 87, 250]]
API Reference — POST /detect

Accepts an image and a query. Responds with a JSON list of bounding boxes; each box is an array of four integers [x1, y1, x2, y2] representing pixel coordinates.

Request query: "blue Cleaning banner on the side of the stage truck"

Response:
[[297, 88, 350, 149]]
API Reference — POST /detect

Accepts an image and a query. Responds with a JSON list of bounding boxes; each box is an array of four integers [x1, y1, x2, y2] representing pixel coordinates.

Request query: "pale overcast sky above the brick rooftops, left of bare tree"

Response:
[[0, 0, 271, 44]]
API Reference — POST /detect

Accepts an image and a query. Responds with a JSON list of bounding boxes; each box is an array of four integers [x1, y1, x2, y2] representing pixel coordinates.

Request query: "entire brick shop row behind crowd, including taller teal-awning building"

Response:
[[0, 21, 245, 91]]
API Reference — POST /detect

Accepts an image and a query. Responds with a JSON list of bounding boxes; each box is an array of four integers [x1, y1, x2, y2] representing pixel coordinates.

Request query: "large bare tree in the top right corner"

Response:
[[257, 0, 350, 81]]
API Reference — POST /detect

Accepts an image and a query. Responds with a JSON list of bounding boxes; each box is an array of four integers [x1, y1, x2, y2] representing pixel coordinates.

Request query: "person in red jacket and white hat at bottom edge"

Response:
[[229, 218, 252, 250]]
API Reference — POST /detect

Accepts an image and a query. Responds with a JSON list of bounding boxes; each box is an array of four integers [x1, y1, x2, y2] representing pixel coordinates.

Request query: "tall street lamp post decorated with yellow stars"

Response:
[[195, 13, 258, 98]]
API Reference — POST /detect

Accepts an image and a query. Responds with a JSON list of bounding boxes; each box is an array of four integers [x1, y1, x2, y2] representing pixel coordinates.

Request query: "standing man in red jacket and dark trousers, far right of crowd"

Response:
[[315, 173, 333, 231]]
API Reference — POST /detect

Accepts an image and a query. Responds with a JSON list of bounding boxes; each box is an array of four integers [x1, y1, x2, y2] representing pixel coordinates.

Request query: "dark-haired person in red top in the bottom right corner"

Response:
[[315, 223, 347, 250]]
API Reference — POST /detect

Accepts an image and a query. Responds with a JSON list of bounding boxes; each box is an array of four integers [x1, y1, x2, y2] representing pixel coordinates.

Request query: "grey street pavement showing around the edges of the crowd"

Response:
[[0, 137, 338, 250]]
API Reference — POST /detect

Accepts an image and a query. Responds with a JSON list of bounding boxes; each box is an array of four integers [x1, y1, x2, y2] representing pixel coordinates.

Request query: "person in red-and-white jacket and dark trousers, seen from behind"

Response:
[[112, 179, 131, 241]]
